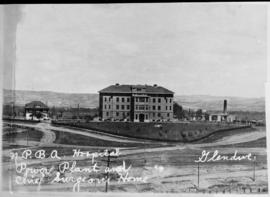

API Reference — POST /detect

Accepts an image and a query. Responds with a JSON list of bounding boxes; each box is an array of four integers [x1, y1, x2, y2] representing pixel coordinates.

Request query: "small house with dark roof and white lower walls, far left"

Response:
[[24, 101, 49, 120]]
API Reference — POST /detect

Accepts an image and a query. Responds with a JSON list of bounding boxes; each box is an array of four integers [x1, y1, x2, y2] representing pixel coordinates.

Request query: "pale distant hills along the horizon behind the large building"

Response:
[[3, 90, 265, 112]]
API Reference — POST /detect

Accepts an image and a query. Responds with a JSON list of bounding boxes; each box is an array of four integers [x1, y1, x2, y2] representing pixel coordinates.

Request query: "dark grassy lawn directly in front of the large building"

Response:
[[53, 121, 247, 142]]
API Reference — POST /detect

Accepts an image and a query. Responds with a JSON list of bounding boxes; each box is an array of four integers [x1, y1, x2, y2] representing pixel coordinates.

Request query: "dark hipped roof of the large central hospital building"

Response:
[[99, 84, 174, 94]]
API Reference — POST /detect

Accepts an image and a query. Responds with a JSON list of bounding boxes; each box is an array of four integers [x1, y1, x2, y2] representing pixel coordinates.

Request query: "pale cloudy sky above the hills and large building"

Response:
[[2, 3, 267, 97]]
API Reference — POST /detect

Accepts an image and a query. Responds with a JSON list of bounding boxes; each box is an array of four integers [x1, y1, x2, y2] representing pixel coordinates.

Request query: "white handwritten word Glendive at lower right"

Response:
[[195, 150, 252, 163]]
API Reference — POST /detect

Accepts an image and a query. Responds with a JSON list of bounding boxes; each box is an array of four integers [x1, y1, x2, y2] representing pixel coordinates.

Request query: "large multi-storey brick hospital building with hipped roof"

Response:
[[99, 84, 174, 122]]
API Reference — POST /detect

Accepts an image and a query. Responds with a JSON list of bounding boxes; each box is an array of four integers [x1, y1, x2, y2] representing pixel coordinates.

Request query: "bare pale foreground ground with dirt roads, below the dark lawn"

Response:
[[3, 121, 268, 193]]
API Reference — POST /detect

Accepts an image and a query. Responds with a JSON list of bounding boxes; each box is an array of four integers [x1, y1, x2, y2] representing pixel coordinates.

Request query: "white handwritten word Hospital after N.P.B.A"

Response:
[[73, 148, 120, 163]]
